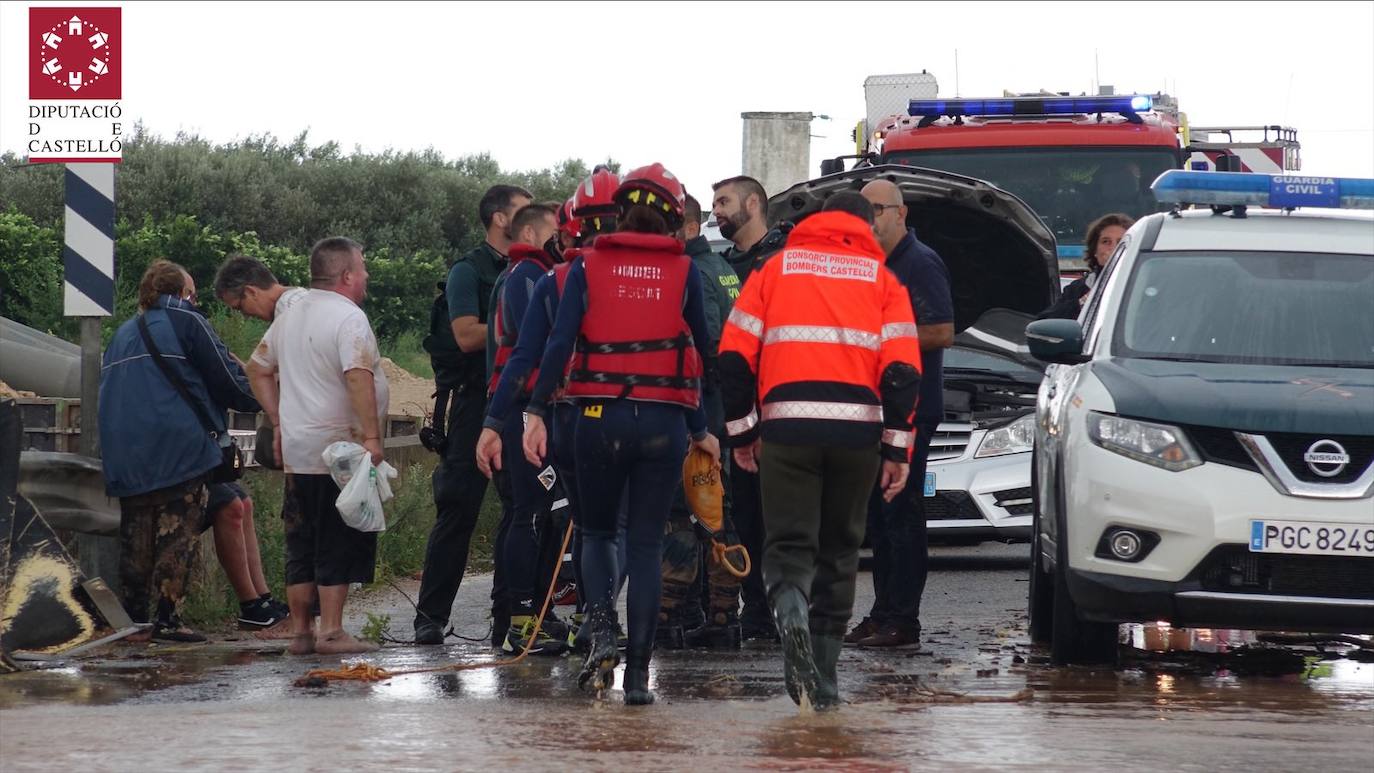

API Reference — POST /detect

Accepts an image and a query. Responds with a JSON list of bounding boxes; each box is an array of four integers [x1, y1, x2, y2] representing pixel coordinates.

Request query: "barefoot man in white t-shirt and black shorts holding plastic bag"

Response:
[[249, 236, 390, 655]]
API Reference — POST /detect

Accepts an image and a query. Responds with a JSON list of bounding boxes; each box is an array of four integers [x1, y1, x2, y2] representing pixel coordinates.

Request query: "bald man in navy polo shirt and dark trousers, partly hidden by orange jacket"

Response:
[[845, 180, 954, 649]]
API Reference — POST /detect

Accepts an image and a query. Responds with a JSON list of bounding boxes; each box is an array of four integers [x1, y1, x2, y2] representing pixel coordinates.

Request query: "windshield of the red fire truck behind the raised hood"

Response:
[[885, 147, 1178, 244]]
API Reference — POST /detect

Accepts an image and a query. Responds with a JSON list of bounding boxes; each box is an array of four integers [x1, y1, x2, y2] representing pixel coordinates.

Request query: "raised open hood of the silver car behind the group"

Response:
[[768, 165, 1059, 333]]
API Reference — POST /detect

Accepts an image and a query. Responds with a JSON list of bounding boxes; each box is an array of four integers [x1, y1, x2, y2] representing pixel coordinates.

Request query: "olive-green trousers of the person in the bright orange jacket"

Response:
[[758, 441, 882, 636]]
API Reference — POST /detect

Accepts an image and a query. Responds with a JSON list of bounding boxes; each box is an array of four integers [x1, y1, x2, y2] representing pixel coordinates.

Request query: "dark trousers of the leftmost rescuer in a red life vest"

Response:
[[502, 405, 554, 615]]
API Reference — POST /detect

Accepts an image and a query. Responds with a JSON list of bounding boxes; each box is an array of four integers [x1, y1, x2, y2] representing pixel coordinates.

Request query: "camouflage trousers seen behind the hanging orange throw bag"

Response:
[[661, 508, 741, 625]]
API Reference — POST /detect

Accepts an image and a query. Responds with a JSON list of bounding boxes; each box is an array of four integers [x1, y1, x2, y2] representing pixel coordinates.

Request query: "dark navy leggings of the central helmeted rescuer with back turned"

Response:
[[576, 400, 688, 652]]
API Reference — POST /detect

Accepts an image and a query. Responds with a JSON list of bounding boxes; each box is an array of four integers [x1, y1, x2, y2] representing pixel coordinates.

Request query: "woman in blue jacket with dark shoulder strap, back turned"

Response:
[[99, 259, 260, 641]]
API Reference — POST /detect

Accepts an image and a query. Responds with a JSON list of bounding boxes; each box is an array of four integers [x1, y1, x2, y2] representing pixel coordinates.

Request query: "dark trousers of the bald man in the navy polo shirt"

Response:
[[868, 422, 940, 636]]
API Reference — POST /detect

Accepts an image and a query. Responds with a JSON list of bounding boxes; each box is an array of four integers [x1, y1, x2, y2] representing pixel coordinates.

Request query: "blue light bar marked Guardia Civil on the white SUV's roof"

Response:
[[1150, 169, 1374, 209]]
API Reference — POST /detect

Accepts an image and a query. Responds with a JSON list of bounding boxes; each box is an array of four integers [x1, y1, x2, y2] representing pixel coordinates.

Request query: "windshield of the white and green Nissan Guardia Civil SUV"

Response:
[[1113, 251, 1374, 368]]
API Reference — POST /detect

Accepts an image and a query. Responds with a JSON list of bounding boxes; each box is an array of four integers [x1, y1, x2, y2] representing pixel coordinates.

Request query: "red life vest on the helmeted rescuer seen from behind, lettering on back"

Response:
[[567, 233, 702, 408]]
